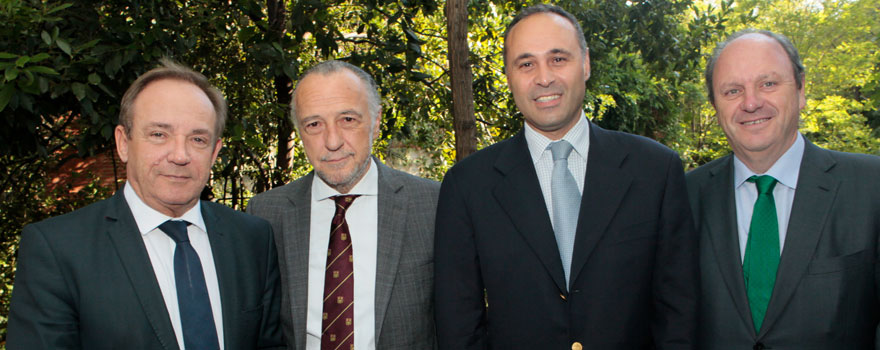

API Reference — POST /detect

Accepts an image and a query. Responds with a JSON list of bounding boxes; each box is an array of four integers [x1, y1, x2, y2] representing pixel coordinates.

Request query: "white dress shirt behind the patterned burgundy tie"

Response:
[[306, 159, 379, 350]]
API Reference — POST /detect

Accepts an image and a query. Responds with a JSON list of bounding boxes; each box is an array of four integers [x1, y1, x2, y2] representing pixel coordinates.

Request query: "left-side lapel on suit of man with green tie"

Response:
[[698, 156, 755, 333]]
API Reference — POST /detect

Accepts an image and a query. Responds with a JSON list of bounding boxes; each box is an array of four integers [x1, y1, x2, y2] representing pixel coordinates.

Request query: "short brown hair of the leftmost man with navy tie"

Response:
[[119, 58, 227, 139]]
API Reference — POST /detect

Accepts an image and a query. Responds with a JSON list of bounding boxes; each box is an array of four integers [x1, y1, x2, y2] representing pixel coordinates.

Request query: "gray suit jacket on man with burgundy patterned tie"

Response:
[[248, 159, 440, 350]]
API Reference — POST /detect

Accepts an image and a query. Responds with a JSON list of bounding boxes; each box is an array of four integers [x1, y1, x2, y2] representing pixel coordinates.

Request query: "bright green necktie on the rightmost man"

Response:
[[743, 175, 779, 333]]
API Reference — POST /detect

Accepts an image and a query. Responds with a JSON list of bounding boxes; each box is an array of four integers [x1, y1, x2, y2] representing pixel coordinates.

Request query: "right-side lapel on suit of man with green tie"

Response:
[[761, 140, 840, 335]]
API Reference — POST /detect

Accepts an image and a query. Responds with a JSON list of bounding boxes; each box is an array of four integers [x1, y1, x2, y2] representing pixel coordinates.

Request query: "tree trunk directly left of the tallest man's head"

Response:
[[446, 0, 477, 162]]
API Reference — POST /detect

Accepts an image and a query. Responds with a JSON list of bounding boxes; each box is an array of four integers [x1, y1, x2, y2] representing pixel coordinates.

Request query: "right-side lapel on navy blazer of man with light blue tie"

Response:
[[570, 123, 632, 283]]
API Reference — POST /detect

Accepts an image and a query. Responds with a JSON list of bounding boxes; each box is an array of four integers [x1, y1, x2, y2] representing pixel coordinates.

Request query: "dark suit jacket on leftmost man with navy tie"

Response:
[[6, 191, 284, 350]]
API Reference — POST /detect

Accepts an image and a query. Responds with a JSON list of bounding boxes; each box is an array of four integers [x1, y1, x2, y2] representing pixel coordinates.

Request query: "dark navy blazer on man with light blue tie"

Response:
[[434, 124, 698, 350]]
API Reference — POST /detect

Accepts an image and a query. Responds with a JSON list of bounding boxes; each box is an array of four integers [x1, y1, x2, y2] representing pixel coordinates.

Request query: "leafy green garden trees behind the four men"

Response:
[[0, 0, 880, 349]]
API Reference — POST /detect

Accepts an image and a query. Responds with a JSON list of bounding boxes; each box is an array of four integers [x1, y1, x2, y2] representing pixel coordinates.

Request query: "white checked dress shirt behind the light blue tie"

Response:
[[525, 112, 590, 231]]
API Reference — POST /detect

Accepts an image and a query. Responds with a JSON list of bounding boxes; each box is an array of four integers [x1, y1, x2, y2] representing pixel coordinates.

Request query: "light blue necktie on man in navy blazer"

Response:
[[549, 140, 581, 288]]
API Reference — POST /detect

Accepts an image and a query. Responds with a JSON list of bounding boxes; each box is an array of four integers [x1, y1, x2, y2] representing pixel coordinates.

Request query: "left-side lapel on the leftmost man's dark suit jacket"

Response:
[[104, 190, 179, 350]]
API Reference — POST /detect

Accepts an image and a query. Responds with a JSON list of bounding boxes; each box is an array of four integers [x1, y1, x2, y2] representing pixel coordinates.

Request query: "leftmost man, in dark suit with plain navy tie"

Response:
[[6, 61, 284, 350]]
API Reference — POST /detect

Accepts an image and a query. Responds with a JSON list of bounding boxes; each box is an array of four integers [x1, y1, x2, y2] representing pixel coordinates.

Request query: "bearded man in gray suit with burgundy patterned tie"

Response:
[[248, 61, 439, 350]]
